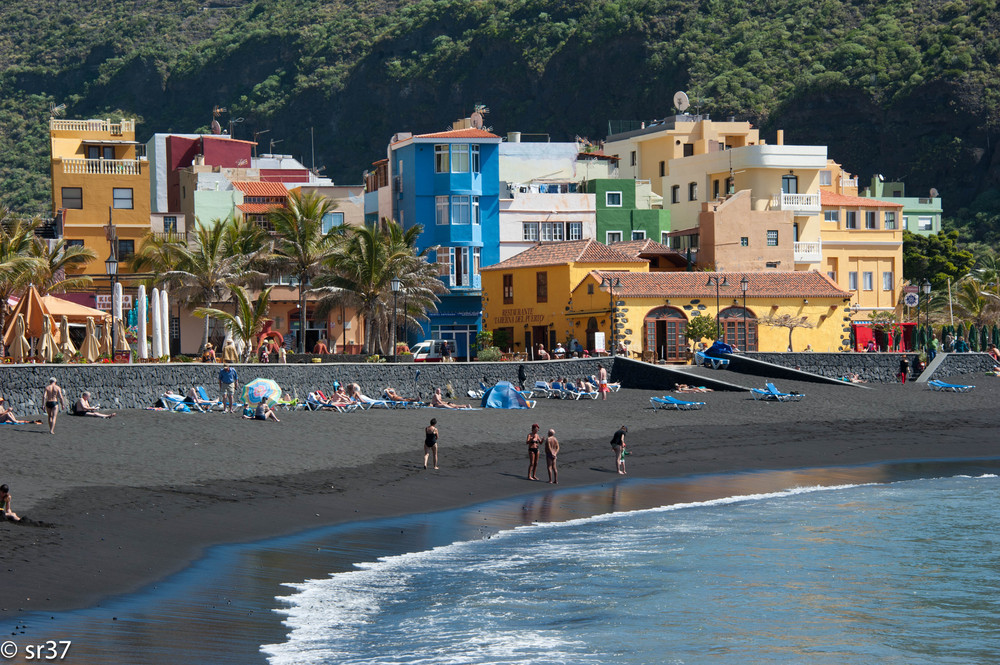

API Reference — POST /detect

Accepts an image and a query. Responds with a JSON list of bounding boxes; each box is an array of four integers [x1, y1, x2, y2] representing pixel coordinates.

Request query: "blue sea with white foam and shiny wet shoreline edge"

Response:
[[0, 460, 1000, 665]]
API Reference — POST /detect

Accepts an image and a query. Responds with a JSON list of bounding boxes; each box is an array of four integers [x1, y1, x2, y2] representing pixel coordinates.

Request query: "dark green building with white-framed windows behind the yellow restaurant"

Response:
[[587, 178, 670, 245]]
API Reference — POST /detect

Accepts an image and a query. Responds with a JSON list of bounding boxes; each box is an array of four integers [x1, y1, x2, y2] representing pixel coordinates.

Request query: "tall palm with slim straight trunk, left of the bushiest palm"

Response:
[[270, 192, 338, 353]]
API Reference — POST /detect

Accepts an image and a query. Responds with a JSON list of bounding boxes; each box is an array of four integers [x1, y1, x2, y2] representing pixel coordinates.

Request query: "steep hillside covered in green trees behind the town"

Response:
[[0, 0, 1000, 233]]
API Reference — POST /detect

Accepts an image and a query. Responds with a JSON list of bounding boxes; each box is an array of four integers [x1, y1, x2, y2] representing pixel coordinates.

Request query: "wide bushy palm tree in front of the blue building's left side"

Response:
[[315, 219, 447, 354]]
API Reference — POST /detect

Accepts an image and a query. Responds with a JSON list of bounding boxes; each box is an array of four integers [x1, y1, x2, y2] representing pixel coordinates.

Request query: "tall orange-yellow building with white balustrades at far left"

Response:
[[49, 118, 150, 275]]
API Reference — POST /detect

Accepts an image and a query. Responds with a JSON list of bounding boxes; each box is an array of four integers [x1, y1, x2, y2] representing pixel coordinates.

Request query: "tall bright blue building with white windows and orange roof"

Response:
[[388, 121, 500, 358]]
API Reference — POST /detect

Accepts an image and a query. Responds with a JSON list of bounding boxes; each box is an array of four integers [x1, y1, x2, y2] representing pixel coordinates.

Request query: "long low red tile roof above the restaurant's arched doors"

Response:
[[590, 270, 851, 301]]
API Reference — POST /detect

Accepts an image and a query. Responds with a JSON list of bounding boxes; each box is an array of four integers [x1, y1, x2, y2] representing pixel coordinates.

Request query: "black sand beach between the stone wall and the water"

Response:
[[0, 376, 1000, 617]]
